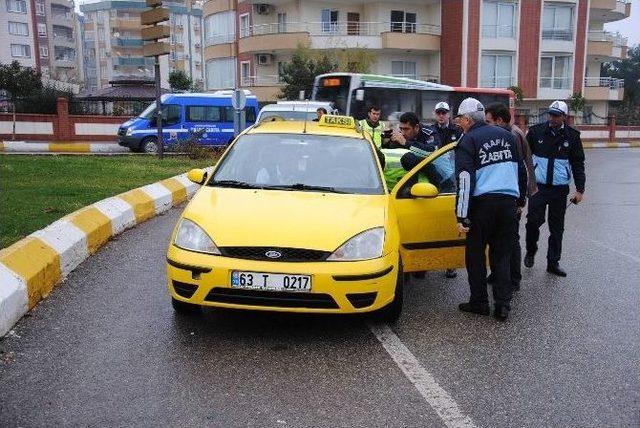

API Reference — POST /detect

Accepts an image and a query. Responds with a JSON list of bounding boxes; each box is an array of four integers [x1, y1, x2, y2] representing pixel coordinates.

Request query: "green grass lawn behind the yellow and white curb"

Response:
[[0, 155, 214, 248]]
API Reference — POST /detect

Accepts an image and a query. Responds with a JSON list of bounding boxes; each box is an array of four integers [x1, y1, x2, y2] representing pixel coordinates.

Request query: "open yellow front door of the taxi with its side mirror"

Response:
[[390, 143, 465, 272]]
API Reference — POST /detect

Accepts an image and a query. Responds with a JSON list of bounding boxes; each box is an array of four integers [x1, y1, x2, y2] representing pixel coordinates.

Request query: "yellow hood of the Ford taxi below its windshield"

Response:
[[183, 186, 388, 251]]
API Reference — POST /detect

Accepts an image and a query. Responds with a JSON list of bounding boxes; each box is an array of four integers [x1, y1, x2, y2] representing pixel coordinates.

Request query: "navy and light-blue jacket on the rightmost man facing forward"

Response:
[[527, 122, 586, 193]]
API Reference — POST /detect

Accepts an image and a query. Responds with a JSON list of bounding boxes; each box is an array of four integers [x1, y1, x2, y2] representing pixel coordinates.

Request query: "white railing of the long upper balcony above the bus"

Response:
[[240, 21, 440, 37]]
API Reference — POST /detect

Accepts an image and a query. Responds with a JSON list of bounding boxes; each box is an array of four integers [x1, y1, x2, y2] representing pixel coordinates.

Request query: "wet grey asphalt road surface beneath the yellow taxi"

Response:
[[0, 149, 640, 427]]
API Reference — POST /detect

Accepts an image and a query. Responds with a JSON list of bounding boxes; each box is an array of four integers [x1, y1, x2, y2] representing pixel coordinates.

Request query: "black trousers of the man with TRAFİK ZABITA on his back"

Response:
[[465, 195, 517, 309]]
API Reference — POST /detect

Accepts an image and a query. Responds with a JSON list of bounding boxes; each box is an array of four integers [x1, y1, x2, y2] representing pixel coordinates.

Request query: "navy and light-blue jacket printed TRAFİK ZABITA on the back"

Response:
[[455, 122, 527, 224]]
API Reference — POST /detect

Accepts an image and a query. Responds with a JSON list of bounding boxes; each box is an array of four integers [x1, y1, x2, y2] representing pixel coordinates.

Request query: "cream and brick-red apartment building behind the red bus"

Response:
[[203, 0, 630, 115]]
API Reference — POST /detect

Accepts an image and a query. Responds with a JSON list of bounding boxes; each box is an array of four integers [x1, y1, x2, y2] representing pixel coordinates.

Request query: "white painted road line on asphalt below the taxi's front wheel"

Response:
[[369, 324, 475, 428]]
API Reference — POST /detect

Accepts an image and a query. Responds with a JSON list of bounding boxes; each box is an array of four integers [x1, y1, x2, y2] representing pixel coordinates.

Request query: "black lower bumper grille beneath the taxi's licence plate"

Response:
[[205, 287, 339, 309]]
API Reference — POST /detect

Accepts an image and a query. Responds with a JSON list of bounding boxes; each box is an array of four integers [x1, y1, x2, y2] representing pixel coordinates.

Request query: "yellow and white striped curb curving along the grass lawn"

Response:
[[0, 168, 212, 337]]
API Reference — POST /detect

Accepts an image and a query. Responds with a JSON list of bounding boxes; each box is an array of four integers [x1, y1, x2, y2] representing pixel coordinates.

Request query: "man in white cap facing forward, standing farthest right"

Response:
[[524, 100, 586, 277]]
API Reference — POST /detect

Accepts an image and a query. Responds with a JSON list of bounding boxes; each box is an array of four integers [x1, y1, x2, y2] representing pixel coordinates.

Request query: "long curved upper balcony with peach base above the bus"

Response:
[[239, 21, 440, 53]]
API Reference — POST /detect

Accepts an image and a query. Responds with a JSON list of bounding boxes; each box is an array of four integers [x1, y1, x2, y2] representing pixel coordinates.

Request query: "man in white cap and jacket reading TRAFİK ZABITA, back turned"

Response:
[[455, 98, 527, 321]]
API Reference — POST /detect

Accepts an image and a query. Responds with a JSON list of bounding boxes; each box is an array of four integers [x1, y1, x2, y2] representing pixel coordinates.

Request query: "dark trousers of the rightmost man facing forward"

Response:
[[526, 184, 569, 265]]
